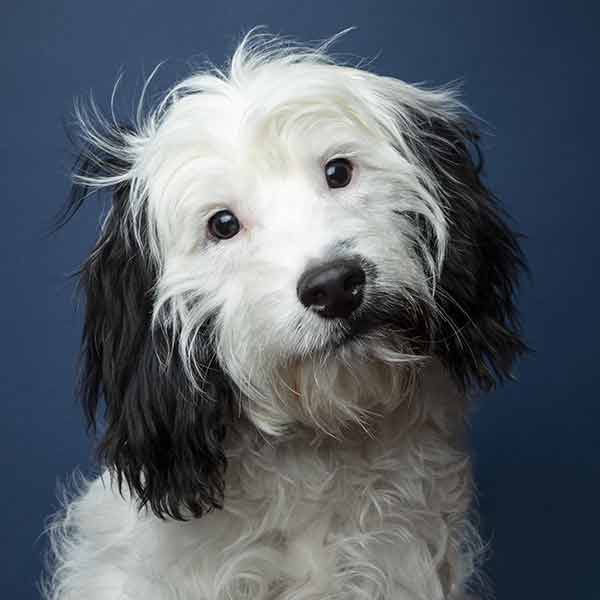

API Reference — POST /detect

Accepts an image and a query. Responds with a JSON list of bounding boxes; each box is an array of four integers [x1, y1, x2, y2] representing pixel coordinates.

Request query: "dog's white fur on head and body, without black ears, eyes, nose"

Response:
[[46, 36, 488, 600]]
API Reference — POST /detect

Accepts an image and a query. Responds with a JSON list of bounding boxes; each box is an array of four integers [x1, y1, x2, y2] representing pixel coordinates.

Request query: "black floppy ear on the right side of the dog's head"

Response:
[[416, 118, 526, 389]]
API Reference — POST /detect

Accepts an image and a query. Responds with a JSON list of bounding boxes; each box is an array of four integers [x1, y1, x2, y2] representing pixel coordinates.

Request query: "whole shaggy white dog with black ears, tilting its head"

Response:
[[43, 32, 526, 600]]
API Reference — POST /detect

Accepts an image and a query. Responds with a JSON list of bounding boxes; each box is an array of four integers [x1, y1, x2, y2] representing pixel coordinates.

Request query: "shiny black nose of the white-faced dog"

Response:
[[298, 259, 366, 319]]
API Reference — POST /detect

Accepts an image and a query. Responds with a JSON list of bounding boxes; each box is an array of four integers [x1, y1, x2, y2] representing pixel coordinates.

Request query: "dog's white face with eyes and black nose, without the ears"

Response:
[[144, 63, 447, 418]]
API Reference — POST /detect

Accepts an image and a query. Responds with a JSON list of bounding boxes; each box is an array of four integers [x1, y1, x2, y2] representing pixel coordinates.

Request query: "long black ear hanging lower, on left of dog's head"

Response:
[[67, 131, 231, 519]]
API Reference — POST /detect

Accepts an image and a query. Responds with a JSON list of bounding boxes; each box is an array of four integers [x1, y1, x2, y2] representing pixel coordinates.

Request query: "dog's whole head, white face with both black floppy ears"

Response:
[[63, 34, 524, 518]]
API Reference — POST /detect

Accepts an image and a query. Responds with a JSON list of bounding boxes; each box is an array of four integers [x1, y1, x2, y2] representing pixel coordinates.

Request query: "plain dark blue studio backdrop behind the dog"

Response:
[[0, 0, 600, 600]]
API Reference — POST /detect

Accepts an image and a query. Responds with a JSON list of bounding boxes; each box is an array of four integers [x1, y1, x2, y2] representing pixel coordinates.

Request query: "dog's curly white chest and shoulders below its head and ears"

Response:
[[45, 368, 479, 600]]
